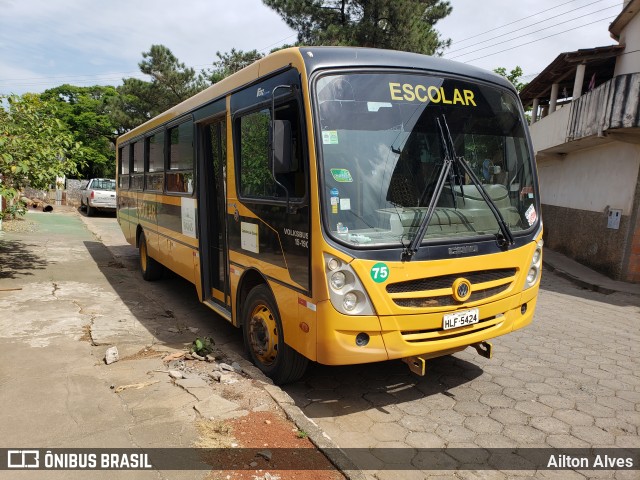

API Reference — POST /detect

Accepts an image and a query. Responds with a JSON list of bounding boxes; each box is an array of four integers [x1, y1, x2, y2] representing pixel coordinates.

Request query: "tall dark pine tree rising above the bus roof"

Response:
[[263, 0, 451, 55]]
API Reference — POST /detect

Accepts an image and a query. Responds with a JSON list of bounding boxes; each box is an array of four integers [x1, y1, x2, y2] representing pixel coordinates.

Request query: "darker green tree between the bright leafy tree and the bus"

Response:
[[41, 85, 117, 178]]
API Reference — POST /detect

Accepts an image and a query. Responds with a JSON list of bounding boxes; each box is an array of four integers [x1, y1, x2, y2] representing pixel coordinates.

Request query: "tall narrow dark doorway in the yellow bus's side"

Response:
[[198, 115, 231, 310]]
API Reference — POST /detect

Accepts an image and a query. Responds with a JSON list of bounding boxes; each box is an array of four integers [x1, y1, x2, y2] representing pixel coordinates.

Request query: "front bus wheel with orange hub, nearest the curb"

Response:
[[242, 285, 309, 385]]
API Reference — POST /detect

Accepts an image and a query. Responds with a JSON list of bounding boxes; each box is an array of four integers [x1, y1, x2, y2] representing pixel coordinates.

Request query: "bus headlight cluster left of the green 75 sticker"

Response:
[[324, 254, 375, 315]]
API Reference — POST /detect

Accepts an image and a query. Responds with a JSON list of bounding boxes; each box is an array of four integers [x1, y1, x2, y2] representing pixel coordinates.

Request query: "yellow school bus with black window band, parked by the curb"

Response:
[[117, 47, 542, 383]]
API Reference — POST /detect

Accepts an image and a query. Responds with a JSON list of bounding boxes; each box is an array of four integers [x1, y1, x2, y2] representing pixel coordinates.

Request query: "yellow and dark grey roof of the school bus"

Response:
[[118, 47, 515, 143]]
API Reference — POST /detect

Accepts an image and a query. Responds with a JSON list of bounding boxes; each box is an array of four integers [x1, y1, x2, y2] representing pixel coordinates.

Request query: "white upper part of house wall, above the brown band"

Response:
[[538, 142, 640, 215]]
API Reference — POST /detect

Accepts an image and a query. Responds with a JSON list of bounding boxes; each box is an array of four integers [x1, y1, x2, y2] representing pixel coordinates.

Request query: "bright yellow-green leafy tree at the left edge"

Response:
[[0, 93, 82, 216]]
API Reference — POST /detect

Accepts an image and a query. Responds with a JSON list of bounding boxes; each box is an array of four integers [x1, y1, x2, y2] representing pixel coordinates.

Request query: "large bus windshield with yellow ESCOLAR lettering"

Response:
[[315, 73, 538, 251]]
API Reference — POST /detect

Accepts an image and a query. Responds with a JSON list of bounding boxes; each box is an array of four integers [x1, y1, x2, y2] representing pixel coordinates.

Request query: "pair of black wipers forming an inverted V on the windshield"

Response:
[[402, 115, 514, 260]]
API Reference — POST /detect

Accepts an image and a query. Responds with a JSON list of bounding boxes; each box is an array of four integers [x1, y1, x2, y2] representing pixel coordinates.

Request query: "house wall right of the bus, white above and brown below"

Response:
[[538, 142, 640, 281]]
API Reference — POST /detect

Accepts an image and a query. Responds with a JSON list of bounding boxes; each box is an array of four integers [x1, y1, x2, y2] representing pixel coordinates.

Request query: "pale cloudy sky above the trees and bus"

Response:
[[0, 0, 622, 94]]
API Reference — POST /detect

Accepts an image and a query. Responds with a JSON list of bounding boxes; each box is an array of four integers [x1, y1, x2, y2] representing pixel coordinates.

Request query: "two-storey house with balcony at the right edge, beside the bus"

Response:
[[520, 0, 640, 283]]
